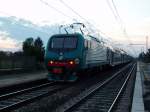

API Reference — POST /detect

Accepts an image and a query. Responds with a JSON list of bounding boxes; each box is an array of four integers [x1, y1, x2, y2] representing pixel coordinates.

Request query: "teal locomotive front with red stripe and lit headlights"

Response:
[[45, 34, 83, 81]]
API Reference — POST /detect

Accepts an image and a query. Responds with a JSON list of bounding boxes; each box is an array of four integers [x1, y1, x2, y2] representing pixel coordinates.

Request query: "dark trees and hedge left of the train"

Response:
[[0, 37, 45, 69]]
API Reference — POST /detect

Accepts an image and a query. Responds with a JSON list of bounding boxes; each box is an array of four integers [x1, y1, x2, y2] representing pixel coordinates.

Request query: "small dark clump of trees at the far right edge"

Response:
[[139, 49, 150, 63]]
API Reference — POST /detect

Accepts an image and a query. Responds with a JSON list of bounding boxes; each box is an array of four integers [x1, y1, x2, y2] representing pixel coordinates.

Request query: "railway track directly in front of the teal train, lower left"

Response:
[[0, 82, 68, 112]]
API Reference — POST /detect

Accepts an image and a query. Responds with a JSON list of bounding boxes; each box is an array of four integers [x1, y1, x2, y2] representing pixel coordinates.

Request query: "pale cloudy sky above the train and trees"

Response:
[[0, 0, 150, 56]]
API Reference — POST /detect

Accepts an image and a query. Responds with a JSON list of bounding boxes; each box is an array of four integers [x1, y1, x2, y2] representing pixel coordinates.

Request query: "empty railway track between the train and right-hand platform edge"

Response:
[[56, 64, 136, 112]]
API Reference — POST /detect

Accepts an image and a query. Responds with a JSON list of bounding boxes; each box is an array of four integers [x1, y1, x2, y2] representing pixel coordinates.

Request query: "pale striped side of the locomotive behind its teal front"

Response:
[[84, 35, 109, 68]]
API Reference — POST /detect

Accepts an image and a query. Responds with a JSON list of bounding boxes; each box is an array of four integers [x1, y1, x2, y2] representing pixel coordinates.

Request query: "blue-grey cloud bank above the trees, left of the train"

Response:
[[0, 16, 58, 45]]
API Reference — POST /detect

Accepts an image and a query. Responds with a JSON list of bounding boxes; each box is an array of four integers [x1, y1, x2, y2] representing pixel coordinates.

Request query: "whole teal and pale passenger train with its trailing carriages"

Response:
[[44, 23, 132, 82]]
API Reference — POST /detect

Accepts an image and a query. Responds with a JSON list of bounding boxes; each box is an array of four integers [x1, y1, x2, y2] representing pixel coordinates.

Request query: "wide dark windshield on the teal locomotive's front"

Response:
[[49, 37, 77, 50]]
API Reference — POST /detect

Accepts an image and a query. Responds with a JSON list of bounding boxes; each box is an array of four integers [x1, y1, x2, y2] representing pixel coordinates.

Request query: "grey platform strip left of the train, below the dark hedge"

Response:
[[0, 71, 47, 88]]
